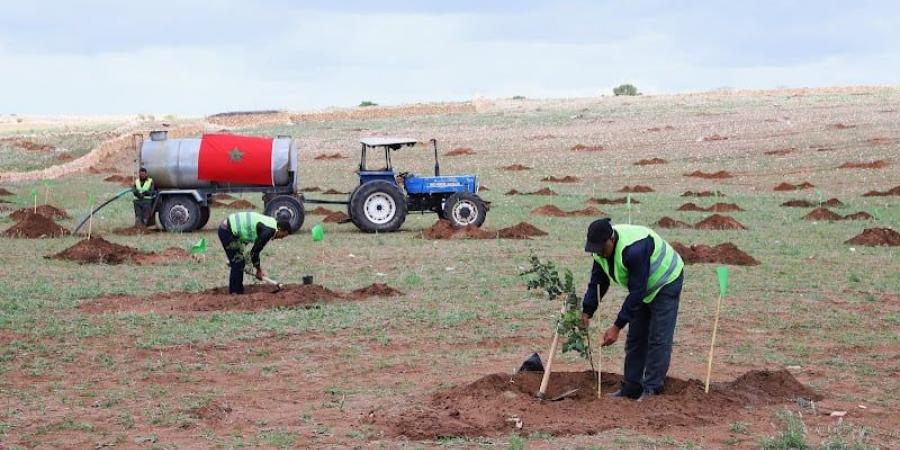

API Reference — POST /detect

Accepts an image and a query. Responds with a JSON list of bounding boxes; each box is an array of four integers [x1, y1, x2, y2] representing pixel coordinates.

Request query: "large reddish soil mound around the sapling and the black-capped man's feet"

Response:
[[372, 370, 821, 439]]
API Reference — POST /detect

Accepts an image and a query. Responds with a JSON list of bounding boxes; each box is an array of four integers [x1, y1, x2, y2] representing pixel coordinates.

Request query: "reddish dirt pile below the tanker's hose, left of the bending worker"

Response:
[[48, 236, 188, 265]]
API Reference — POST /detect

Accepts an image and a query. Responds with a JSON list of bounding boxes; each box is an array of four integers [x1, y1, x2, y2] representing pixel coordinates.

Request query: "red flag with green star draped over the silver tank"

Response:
[[197, 134, 274, 186]]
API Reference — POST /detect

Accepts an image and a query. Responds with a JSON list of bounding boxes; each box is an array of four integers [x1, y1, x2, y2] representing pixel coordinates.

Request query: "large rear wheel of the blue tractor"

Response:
[[348, 180, 406, 233]]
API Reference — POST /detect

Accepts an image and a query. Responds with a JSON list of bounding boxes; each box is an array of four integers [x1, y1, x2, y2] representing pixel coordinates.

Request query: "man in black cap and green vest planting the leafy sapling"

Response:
[[581, 219, 684, 400]]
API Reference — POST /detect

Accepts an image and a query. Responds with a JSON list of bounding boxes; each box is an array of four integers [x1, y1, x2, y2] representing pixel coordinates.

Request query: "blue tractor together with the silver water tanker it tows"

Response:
[[135, 131, 487, 232]]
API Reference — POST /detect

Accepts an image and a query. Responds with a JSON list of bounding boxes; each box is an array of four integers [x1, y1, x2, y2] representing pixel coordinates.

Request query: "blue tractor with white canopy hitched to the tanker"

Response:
[[347, 137, 487, 233]]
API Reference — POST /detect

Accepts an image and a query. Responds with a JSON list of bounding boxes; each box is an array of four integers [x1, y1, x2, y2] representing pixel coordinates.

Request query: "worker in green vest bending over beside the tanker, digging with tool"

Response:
[[219, 212, 292, 294]]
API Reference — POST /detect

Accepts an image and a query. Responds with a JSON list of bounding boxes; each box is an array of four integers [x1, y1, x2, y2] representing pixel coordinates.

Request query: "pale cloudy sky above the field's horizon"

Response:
[[0, 0, 900, 116]]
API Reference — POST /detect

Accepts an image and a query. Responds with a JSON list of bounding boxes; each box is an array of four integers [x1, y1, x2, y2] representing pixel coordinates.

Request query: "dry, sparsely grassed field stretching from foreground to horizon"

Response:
[[0, 88, 900, 449]]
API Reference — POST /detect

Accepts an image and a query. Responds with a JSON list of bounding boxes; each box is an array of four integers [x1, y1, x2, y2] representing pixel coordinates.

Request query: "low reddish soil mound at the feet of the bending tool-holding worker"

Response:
[[79, 282, 402, 313]]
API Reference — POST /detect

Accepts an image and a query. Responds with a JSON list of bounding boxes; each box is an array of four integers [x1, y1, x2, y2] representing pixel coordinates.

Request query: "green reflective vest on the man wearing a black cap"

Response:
[[593, 225, 684, 303]]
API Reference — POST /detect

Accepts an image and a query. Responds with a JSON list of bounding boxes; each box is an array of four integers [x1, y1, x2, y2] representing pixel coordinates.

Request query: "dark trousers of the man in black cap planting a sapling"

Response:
[[622, 273, 684, 397]]
